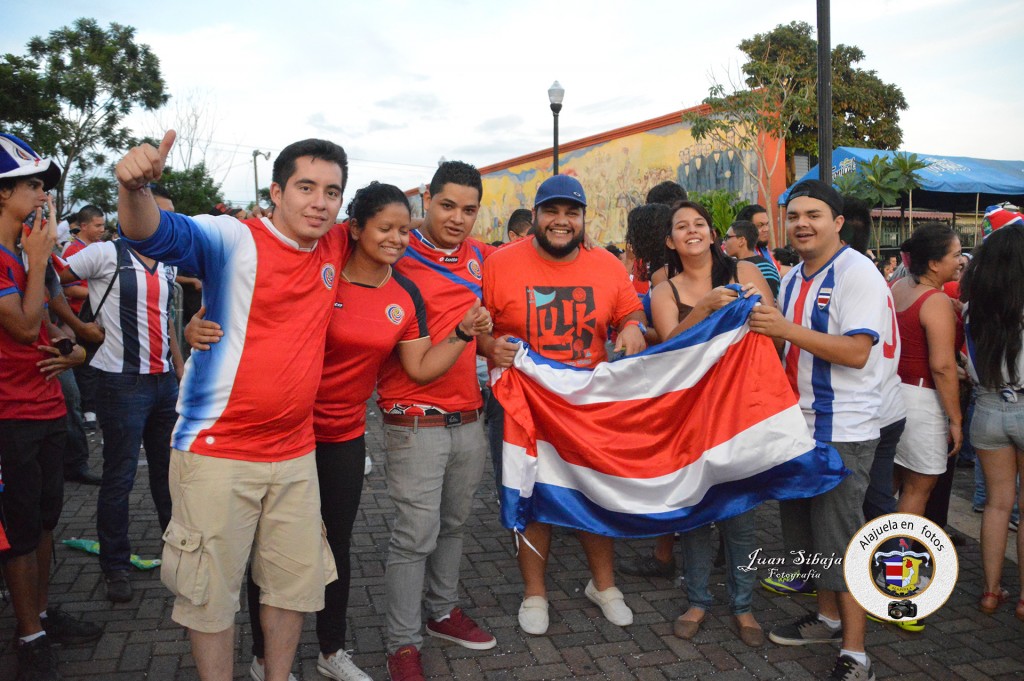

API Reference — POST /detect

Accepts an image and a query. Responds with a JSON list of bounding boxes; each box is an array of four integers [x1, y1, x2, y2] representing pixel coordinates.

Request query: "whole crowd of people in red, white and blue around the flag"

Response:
[[0, 124, 1024, 681]]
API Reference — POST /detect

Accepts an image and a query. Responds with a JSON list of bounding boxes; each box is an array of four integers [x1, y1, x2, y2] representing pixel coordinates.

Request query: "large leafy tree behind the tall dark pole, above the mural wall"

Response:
[[739, 22, 907, 157]]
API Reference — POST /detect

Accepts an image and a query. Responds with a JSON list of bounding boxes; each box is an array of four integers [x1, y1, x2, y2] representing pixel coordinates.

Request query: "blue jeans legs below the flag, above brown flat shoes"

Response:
[[680, 509, 758, 614]]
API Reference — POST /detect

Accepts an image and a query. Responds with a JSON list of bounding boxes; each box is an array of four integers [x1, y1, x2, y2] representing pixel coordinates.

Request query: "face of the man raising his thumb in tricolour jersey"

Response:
[[270, 156, 344, 248]]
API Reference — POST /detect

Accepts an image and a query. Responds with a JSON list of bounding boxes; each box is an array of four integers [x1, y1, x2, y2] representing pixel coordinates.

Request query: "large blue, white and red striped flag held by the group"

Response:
[[493, 296, 849, 538]]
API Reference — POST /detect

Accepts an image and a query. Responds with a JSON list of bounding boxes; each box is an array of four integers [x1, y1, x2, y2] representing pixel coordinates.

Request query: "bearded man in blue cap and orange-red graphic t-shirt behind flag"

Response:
[[479, 175, 646, 634]]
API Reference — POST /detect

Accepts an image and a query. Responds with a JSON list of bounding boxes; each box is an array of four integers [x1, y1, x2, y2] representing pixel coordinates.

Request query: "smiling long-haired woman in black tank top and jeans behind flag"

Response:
[[651, 202, 775, 646]]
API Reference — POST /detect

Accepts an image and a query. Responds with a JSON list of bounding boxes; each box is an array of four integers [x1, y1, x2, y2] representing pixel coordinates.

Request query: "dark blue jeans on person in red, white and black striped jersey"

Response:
[[96, 371, 178, 572]]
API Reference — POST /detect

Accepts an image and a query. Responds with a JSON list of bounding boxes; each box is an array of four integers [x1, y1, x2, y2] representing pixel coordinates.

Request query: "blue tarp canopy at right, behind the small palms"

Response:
[[778, 146, 1024, 212]]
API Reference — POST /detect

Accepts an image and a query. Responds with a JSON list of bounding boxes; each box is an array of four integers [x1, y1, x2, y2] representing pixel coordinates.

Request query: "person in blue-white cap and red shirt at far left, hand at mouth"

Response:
[[0, 135, 102, 679]]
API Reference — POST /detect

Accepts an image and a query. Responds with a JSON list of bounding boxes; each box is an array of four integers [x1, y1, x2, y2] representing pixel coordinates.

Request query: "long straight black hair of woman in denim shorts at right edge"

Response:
[[961, 225, 1024, 389]]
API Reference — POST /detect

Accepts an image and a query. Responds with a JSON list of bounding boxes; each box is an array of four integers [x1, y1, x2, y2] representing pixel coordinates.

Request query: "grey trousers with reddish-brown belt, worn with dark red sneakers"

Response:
[[384, 419, 487, 652]]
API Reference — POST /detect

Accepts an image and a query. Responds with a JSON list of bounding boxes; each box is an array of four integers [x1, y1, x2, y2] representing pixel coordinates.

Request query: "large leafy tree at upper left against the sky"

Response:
[[0, 18, 168, 212]]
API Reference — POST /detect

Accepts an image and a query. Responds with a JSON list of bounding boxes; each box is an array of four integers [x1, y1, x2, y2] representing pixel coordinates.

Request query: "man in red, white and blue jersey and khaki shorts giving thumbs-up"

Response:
[[116, 131, 349, 681]]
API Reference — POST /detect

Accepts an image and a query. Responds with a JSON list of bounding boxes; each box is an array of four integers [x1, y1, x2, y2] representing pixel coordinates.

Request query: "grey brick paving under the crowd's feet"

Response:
[[0, 401, 1024, 681]]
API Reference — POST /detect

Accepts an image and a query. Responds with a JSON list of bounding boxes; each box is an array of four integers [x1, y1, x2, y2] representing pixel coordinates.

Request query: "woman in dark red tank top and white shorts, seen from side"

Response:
[[892, 222, 964, 515]]
